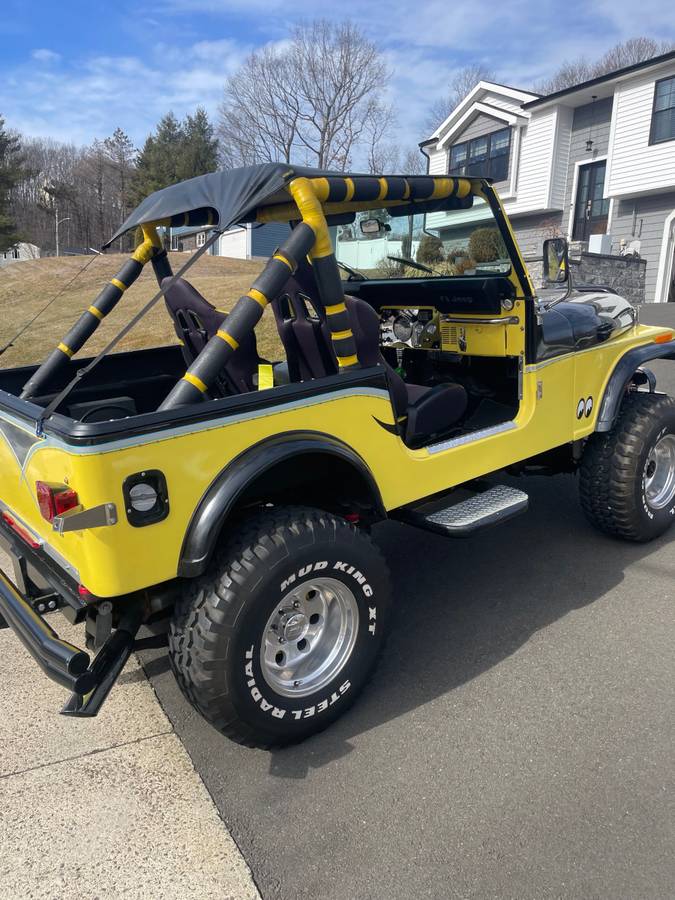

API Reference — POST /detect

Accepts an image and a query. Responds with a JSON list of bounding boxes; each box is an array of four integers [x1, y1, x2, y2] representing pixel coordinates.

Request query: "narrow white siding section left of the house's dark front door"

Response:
[[507, 108, 557, 213]]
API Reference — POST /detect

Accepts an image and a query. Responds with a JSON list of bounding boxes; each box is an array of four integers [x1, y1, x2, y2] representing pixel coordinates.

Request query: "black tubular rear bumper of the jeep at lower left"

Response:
[[0, 572, 94, 694]]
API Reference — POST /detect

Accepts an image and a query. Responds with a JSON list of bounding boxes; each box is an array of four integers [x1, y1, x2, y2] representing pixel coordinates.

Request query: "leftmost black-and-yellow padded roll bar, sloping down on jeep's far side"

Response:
[[21, 225, 164, 399]]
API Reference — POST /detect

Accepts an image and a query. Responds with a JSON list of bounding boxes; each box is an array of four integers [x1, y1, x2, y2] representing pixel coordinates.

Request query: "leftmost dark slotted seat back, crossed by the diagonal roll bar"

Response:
[[162, 278, 260, 396]]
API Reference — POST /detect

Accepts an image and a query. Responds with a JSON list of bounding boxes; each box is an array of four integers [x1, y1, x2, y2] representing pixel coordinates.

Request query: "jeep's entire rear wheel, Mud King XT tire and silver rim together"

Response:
[[169, 507, 389, 747]]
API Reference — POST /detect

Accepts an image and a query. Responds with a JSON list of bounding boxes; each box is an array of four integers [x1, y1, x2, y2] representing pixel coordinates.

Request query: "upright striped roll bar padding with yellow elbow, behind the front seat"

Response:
[[288, 178, 362, 370]]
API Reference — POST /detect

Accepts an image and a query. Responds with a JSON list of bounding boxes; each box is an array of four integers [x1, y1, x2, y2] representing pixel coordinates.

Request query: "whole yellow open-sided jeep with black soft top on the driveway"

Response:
[[0, 164, 675, 747]]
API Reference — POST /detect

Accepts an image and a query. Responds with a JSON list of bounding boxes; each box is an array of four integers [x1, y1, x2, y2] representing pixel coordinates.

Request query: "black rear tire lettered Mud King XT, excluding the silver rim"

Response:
[[169, 507, 390, 748]]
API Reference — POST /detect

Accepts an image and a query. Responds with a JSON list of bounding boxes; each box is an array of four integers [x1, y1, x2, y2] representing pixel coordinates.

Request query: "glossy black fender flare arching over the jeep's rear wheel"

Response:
[[178, 432, 387, 578]]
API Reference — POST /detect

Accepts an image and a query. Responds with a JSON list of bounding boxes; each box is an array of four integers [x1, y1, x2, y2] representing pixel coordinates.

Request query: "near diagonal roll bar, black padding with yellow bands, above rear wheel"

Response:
[[159, 223, 315, 410]]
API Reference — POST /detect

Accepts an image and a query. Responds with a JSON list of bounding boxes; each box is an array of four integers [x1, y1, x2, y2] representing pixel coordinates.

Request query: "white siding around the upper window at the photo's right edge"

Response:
[[605, 64, 675, 197]]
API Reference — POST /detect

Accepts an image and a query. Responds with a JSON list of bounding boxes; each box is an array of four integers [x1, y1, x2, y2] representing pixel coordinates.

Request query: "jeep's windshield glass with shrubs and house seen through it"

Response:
[[335, 203, 511, 278]]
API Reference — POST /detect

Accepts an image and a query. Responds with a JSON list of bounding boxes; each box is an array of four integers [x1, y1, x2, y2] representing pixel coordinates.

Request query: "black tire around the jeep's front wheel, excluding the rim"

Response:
[[580, 392, 675, 542]]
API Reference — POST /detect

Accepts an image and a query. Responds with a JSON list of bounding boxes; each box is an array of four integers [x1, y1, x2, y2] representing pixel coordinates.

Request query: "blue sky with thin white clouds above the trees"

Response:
[[0, 0, 675, 148]]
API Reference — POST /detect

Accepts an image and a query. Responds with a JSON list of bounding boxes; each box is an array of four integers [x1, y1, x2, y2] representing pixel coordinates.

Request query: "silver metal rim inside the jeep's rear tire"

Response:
[[260, 577, 359, 697]]
